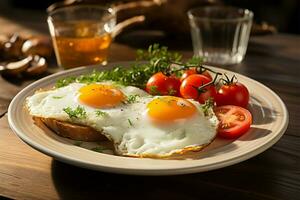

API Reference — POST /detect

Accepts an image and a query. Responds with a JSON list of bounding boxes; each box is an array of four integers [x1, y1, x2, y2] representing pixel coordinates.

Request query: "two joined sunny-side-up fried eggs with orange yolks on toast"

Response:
[[26, 82, 218, 157]]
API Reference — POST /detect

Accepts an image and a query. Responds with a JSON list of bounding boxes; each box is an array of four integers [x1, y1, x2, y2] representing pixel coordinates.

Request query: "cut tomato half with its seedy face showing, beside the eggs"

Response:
[[214, 105, 252, 139]]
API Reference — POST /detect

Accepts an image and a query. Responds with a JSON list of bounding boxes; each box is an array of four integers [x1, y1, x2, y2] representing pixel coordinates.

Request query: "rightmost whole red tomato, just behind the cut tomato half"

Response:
[[216, 82, 249, 108]]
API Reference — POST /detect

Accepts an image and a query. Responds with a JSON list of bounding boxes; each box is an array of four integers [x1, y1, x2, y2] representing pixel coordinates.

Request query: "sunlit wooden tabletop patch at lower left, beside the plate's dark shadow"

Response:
[[0, 116, 57, 199]]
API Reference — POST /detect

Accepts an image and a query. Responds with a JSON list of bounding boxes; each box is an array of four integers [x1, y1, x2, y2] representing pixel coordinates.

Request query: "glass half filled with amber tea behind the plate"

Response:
[[48, 5, 116, 69]]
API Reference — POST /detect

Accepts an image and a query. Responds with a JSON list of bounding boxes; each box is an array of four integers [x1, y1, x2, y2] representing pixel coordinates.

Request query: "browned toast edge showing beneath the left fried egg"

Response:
[[33, 117, 107, 142]]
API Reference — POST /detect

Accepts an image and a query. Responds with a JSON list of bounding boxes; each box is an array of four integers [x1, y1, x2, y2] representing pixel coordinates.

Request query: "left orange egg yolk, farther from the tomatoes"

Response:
[[78, 83, 125, 108]]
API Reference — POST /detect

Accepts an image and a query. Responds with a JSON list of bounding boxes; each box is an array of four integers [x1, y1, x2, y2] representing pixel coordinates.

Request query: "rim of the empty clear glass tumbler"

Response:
[[187, 6, 254, 23]]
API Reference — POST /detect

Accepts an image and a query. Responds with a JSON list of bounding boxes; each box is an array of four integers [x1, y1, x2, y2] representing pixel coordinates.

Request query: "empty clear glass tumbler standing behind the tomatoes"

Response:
[[188, 6, 253, 65]]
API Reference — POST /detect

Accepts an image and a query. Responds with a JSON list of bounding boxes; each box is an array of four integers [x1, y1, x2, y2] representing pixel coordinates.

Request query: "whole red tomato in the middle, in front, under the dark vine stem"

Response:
[[180, 74, 217, 103]]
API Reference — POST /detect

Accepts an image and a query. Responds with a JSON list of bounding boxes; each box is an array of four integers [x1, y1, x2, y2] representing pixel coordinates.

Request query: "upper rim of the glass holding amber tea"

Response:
[[48, 4, 116, 18]]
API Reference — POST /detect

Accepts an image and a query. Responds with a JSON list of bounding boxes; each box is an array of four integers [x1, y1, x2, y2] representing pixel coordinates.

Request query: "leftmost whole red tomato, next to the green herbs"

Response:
[[146, 72, 180, 96]]
